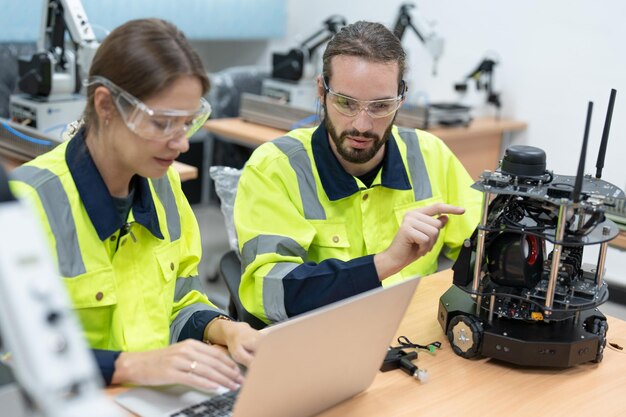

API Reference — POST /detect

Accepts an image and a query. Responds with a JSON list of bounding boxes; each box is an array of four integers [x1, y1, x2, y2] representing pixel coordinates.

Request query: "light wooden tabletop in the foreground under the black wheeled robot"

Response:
[[107, 270, 626, 417]]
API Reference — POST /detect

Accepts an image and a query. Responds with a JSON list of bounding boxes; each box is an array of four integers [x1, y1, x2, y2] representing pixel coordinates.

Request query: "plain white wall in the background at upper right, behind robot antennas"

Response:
[[258, 0, 626, 285]]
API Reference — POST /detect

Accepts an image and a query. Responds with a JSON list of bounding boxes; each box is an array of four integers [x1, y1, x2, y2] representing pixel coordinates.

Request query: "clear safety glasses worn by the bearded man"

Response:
[[322, 77, 406, 119]]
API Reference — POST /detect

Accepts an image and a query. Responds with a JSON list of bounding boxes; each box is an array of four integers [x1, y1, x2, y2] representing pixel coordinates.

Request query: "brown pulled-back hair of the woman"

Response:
[[83, 19, 209, 129]]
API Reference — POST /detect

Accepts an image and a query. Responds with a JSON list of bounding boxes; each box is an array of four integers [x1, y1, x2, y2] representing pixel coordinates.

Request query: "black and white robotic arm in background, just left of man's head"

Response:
[[272, 15, 346, 81]]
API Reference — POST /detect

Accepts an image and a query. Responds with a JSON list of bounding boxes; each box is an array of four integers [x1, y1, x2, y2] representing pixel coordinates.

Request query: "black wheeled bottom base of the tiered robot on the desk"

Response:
[[437, 285, 608, 367]]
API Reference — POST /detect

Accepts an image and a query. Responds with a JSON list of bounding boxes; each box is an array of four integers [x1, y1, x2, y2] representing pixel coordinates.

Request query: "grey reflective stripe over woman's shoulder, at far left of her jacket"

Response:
[[11, 165, 86, 278]]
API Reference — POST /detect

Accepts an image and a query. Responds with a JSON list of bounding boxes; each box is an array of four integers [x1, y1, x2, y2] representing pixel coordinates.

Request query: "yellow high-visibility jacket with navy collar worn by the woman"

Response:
[[11, 130, 220, 351]]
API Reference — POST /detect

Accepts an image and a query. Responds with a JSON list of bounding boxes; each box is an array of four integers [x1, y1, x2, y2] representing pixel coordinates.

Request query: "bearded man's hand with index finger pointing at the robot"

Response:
[[374, 203, 465, 281]]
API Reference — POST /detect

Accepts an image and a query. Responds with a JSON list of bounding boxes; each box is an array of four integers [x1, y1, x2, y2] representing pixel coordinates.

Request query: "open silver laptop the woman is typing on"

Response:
[[115, 278, 419, 417]]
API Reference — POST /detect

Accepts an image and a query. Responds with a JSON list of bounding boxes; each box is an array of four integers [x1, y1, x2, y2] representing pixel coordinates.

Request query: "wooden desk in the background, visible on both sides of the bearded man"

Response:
[[204, 118, 527, 179]]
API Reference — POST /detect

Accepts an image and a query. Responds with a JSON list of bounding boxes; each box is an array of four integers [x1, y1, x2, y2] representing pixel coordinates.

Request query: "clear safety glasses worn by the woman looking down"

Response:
[[85, 76, 211, 141]]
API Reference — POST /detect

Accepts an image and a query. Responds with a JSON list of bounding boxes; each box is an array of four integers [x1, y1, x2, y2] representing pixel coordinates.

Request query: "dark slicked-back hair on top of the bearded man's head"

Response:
[[322, 20, 406, 84]]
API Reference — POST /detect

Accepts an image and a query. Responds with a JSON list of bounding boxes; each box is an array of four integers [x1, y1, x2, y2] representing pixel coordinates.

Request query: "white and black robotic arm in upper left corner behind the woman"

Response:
[[18, 0, 98, 97]]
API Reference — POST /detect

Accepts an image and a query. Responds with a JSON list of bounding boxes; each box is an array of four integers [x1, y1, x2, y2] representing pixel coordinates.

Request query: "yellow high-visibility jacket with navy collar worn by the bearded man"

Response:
[[234, 125, 482, 322]]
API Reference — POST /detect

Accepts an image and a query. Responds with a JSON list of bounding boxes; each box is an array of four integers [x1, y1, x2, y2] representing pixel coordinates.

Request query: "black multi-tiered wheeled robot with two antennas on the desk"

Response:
[[437, 90, 625, 367]]
